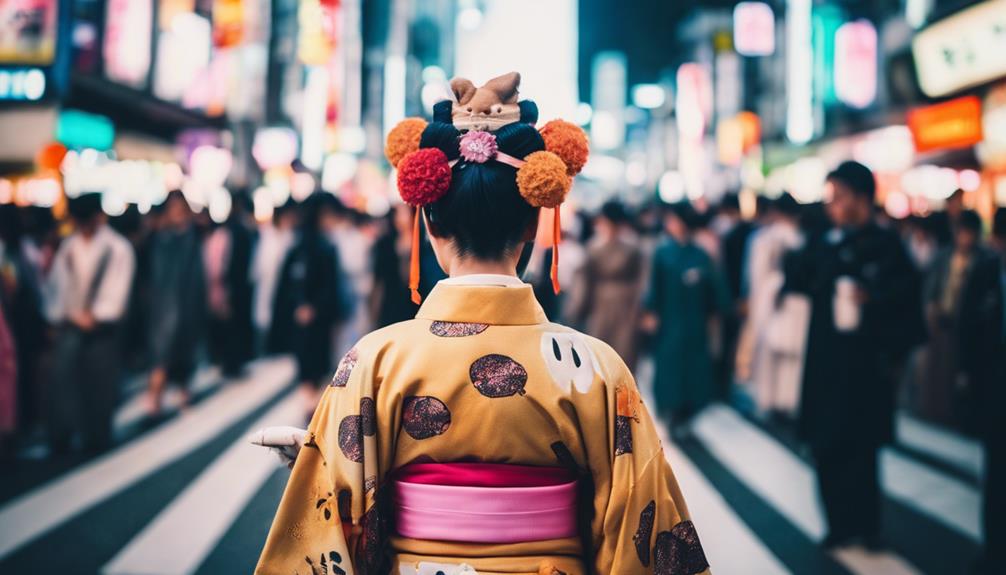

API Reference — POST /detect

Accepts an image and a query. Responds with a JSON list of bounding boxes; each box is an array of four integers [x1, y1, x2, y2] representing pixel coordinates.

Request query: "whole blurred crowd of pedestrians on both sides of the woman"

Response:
[[0, 163, 1006, 562]]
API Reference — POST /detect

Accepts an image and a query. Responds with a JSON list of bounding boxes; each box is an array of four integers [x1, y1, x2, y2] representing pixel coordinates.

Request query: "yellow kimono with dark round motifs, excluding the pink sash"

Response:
[[256, 280, 708, 575]]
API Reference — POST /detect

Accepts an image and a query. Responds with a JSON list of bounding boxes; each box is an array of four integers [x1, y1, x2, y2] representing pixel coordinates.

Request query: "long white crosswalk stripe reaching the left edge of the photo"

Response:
[[0, 358, 294, 558]]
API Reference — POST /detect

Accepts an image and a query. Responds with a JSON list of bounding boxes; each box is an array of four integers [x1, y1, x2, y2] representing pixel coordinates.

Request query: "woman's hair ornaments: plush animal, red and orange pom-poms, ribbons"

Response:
[[384, 72, 590, 304]]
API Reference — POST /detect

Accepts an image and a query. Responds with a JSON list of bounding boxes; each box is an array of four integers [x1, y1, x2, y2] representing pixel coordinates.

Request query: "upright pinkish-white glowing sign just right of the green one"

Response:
[[835, 20, 877, 108]]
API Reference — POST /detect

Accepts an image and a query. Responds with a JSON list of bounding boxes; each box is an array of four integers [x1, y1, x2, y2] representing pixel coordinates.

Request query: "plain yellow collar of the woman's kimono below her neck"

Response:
[[415, 276, 548, 326]]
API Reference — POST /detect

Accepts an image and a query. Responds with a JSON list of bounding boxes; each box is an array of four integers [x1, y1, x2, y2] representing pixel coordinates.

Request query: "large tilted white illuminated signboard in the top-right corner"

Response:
[[911, 0, 1006, 98]]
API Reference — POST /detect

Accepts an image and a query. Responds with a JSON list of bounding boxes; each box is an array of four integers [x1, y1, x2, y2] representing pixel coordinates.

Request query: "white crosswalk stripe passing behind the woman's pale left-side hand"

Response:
[[102, 393, 304, 575]]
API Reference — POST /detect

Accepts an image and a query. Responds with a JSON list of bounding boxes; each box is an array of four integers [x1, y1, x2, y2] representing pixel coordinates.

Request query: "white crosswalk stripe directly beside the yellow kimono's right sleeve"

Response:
[[637, 360, 790, 575]]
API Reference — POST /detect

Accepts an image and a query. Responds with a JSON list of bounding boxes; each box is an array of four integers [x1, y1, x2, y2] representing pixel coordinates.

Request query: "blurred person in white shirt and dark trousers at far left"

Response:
[[46, 194, 136, 452]]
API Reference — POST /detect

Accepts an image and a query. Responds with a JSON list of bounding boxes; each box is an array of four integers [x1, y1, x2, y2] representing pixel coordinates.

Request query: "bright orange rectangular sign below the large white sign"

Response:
[[908, 95, 983, 153]]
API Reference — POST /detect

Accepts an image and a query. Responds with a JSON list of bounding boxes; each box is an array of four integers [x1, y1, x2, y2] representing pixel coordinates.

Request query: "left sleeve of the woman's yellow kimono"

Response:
[[256, 348, 386, 575]]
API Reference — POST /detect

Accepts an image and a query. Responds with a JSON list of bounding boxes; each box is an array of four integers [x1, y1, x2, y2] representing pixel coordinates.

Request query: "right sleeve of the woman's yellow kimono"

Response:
[[595, 369, 709, 575]]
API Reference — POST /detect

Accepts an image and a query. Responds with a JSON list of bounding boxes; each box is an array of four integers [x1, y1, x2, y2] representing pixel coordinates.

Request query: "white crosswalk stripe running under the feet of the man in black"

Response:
[[694, 405, 918, 575]]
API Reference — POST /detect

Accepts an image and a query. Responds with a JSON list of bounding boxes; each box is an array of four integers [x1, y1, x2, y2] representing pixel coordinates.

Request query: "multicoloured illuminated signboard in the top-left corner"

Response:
[[0, 0, 59, 65]]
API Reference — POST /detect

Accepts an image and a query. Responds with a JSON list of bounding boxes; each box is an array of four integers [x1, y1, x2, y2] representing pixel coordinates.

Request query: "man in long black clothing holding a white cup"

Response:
[[787, 162, 925, 548]]
